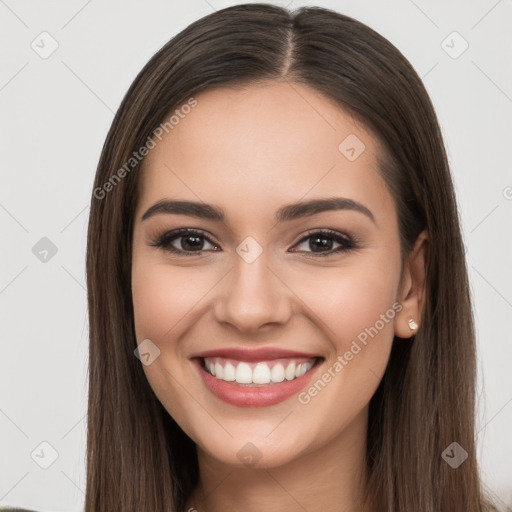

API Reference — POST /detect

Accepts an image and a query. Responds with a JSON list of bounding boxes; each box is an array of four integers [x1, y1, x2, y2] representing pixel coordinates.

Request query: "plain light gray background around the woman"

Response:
[[0, 0, 512, 512]]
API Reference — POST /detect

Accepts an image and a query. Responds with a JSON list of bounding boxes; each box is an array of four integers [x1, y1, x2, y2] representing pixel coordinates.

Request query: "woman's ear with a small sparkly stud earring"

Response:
[[395, 230, 429, 338]]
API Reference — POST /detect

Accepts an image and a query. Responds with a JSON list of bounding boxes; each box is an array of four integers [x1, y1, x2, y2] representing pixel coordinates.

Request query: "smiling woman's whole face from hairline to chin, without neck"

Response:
[[132, 83, 418, 467]]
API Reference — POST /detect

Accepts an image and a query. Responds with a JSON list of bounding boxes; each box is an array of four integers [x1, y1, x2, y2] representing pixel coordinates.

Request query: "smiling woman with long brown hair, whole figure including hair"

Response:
[[85, 4, 498, 512]]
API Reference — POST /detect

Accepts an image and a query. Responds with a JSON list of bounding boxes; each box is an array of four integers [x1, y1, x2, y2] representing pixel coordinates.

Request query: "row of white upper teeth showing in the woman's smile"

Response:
[[205, 358, 314, 384]]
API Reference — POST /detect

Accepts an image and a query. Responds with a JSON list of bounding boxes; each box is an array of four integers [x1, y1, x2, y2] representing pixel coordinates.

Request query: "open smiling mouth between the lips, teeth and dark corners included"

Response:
[[200, 357, 323, 388]]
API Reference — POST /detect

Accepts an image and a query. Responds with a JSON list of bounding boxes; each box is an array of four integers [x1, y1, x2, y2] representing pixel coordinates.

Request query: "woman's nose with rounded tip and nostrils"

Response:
[[214, 255, 294, 334]]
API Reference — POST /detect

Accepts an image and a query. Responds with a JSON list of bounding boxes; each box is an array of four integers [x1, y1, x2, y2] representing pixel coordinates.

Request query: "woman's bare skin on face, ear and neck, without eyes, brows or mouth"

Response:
[[132, 82, 427, 512]]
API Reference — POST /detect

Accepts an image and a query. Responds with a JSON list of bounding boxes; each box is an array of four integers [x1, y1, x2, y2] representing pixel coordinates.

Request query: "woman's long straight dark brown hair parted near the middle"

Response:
[[85, 4, 496, 512]]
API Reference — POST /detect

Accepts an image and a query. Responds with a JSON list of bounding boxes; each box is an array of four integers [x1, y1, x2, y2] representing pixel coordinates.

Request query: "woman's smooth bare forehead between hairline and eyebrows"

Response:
[[137, 82, 392, 226]]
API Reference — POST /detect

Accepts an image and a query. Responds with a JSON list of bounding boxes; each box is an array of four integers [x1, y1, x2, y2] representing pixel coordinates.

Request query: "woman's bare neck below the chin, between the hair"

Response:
[[185, 410, 367, 512]]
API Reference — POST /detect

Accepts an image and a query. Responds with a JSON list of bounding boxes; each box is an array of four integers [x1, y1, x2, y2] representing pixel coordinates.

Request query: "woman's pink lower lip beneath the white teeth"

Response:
[[192, 358, 322, 407]]
